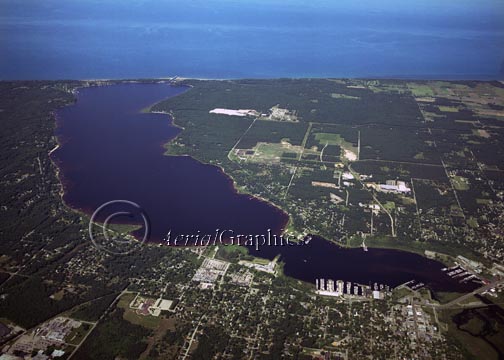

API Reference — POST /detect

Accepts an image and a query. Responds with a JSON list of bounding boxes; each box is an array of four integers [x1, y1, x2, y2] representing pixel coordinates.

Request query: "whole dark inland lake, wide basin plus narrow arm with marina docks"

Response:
[[52, 83, 478, 291]]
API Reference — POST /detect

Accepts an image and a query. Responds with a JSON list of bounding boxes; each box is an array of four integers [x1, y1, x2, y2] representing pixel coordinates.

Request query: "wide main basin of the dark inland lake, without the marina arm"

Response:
[[53, 84, 287, 241]]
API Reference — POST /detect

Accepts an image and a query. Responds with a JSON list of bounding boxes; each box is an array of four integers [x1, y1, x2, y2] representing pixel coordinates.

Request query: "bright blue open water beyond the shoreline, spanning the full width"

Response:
[[0, 0, 504, 79]]
